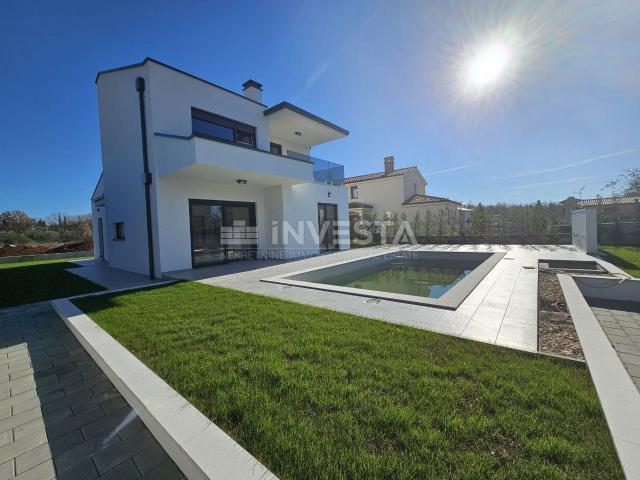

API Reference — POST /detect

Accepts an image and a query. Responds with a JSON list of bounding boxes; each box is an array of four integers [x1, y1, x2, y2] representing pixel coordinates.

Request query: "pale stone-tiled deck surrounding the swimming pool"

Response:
[[167, 245, 620, 352]]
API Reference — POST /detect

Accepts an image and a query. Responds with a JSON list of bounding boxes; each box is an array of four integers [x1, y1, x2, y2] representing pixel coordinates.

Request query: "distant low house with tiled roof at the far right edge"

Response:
[[560, 196, 640, 225]]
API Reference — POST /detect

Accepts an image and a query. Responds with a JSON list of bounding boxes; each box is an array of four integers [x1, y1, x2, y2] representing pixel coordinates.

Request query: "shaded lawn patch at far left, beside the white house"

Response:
[[0, 258, 104, 308]]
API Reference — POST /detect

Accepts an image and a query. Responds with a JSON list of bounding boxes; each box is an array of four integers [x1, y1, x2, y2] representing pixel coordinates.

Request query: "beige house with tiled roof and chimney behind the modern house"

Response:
[[344, 157, 464, 235]]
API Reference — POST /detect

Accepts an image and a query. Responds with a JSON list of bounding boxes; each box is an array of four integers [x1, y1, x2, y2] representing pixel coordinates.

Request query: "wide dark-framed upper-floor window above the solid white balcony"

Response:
[[191, 108, 256, 147]]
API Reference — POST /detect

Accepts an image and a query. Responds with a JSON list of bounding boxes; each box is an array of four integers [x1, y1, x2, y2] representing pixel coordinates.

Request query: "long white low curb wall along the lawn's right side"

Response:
[[558, 274, 640, 479]]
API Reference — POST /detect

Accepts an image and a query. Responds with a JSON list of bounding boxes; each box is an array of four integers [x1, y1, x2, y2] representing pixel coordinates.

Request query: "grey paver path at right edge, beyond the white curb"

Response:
[[588, 298, 640, 389]]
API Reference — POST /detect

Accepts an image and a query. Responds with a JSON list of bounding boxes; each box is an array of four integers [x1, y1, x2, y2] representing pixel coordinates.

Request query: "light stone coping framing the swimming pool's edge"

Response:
[[260, 248, 507, 310]]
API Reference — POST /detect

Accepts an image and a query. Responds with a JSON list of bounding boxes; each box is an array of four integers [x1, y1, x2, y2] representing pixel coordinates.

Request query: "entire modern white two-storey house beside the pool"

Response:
[[91, 58, 349, 277]]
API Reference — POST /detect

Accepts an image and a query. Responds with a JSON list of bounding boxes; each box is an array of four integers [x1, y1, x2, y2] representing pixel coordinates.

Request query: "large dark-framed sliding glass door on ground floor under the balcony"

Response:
[[189, 200, 257, 268]]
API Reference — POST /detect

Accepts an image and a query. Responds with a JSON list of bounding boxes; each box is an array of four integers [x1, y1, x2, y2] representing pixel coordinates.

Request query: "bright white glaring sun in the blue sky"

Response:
[[465, 43, 512, 92]]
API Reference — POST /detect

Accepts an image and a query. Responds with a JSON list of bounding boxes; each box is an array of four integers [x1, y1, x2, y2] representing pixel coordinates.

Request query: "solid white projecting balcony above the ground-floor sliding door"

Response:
[[154, 133, 316, 186]]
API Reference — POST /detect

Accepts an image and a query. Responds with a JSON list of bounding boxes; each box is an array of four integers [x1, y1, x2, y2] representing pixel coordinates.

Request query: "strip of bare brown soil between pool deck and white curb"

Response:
[[538, 270, 584, 360]]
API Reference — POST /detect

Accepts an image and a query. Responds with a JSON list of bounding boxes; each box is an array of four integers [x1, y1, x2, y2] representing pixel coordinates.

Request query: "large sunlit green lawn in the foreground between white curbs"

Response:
[[75, 282, 623, 480]]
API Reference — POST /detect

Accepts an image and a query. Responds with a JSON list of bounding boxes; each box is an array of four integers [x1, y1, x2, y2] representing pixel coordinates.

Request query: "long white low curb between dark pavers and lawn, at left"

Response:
[[50, 296, 277, 480]]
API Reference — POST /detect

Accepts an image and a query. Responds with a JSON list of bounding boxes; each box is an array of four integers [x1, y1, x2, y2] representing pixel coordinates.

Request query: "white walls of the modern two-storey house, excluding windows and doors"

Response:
[[92, 59, 349, 276]]
